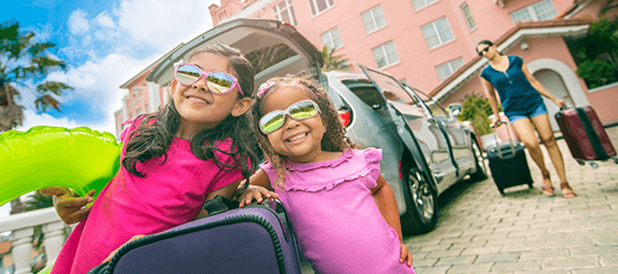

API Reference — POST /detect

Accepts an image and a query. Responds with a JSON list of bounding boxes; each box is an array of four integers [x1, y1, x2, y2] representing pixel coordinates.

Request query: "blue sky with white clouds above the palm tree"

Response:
[[0, 0, 220, 217]]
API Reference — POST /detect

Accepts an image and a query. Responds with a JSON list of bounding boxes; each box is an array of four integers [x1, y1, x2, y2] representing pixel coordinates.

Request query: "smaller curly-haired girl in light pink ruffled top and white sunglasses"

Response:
[[240, 75, 414, 274]]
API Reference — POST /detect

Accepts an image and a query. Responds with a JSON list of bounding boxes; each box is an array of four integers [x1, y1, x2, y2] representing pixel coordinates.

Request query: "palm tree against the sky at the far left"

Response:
[[0, 21, 73, 214]]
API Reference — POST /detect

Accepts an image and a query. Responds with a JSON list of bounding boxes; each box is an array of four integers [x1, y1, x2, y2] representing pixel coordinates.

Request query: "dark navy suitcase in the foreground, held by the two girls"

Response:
[[89, 196, 301, 274]]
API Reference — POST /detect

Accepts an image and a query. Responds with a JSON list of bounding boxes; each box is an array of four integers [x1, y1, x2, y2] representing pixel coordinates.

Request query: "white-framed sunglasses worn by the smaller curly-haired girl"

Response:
[[259, 100, 322, 134]]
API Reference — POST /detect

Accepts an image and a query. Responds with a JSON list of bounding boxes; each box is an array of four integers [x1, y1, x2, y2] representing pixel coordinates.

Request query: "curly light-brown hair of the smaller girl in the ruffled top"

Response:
[[251, 74, 360, 187]]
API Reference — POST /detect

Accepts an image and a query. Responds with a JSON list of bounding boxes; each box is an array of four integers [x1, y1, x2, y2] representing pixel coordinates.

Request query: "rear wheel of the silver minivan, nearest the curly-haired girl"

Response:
[[401, 161, 438, 234]]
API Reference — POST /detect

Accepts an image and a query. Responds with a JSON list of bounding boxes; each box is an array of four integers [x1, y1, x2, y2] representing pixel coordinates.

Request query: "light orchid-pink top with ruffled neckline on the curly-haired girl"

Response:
[[260, 148, 414, 274]]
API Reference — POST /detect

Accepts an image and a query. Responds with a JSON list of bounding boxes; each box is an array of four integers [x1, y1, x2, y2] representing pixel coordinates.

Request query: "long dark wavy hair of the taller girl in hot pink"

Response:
[[122, 44, 259, 191]]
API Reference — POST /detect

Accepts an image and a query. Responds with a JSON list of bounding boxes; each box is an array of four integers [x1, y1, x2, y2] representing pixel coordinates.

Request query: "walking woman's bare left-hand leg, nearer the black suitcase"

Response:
[[512, 118, 560, 194]]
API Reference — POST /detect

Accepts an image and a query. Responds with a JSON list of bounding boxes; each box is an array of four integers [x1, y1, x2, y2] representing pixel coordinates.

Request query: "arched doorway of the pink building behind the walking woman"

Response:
[[533, 69, 575, 131]]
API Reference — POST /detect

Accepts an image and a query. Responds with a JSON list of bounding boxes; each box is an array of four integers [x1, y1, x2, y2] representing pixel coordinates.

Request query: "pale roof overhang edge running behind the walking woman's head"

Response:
[[430, 20, 590, 101]]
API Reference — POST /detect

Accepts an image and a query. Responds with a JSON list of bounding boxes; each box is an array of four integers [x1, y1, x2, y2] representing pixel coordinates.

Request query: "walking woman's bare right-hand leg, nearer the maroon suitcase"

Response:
[[530, 114, 575, 198]]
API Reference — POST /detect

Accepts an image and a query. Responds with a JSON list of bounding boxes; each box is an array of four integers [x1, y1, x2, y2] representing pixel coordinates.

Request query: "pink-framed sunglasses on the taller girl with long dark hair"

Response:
[[174, 63, 244, 95]]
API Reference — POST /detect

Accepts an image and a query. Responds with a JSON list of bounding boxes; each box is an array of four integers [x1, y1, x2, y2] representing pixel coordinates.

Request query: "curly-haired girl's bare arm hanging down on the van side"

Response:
[[371, 174, 412, 266]]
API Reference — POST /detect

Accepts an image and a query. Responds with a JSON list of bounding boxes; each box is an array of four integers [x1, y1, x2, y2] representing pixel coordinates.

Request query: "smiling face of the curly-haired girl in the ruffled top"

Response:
[[260, 85, 326, 163]]
